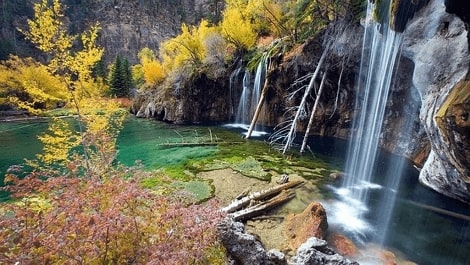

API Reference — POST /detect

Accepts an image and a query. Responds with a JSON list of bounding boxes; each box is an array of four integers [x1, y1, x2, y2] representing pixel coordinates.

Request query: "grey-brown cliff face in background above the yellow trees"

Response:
[[0, 0, 217, 63]]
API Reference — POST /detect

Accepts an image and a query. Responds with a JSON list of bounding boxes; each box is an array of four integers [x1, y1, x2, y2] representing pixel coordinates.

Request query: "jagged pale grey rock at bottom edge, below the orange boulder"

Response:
[[291, 237, 359, 265]]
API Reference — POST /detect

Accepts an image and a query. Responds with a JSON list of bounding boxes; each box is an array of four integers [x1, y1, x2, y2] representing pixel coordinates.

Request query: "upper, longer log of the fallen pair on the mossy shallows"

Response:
[[221, 177, 304, 213]]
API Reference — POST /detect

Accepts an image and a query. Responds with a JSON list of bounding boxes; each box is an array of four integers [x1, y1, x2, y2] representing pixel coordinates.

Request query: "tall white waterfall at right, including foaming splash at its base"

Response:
[[326, 0, 408, 243]]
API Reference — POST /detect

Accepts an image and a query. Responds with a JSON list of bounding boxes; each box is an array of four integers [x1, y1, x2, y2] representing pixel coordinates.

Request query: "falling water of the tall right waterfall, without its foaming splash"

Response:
[[345, 0, 402, 201]]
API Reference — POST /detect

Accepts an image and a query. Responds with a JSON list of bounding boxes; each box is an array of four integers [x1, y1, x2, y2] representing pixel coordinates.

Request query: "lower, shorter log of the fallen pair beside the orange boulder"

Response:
[[229, 190, 295, 221]]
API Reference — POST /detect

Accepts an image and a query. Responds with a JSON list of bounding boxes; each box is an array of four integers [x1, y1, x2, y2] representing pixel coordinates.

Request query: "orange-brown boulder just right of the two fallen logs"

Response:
[[284, 202, 328, 249]]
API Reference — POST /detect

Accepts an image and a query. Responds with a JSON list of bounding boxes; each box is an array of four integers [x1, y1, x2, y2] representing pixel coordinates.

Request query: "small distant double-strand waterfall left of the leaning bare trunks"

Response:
[[235, 54, 268, 124]]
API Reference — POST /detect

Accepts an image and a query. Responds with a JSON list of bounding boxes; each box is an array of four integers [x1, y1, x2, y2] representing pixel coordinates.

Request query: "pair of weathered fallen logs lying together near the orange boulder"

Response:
[[221, 180, 304, 220]]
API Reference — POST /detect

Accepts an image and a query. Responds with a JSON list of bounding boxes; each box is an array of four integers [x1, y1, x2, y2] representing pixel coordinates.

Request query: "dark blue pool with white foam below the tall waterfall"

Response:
[[310, 137, 470, 265]]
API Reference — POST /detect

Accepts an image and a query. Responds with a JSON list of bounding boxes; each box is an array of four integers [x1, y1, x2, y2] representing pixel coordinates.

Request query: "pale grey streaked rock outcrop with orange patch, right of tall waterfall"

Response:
[[403, 0, 470, 203]]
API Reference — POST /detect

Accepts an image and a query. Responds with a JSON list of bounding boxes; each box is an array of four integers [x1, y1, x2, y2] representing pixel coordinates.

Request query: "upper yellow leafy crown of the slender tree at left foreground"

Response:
[[20, 0, 104, 100]]
